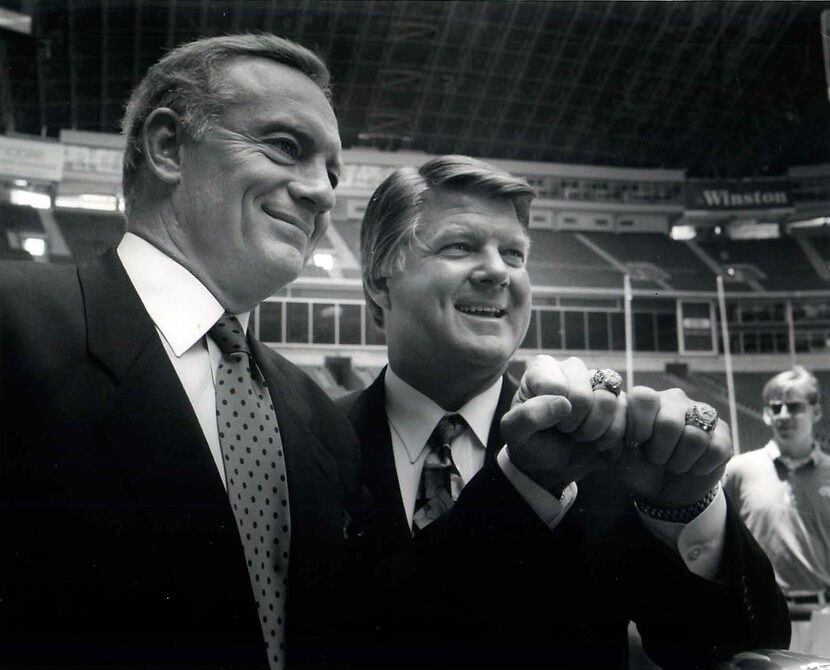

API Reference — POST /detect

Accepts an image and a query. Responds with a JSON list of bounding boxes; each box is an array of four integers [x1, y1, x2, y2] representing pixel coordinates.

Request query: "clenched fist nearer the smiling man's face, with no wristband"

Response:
[[501, 356, 626, 495]]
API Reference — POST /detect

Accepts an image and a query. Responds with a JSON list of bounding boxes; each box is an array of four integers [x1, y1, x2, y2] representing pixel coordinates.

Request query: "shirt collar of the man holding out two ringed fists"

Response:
[[384, 367, 503, 463]]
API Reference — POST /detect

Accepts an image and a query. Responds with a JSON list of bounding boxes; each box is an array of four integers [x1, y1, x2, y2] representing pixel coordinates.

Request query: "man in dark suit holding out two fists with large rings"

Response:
[[339, 156, 789, 668]]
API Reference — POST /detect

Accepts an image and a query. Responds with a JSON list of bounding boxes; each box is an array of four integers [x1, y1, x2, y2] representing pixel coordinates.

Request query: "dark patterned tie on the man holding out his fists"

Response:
[[412, 414, 467, 530]]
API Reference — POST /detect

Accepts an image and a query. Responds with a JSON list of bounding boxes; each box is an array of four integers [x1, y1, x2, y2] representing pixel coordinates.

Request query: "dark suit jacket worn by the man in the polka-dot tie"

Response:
[[0, 251, 359, 668]]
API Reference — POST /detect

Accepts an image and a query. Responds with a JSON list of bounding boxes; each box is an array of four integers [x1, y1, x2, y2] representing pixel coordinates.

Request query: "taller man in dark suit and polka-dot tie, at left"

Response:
[[0, 35, 359, 670]]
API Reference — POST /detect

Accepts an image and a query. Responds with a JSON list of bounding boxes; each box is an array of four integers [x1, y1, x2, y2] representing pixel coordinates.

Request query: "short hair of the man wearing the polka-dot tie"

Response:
[[121, 34, 331, 212]]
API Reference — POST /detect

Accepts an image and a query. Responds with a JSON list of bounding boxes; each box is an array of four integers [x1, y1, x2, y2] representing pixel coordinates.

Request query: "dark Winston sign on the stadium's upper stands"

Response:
[[684, 181, 793, 214]]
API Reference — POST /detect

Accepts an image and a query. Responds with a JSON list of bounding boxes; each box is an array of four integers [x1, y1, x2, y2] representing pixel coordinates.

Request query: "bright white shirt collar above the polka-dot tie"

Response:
[[118, 233, 250, 356]]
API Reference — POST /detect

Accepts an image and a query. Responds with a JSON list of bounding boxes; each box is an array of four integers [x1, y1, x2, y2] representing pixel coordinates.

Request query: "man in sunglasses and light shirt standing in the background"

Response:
[[724, 366, 830, 656]]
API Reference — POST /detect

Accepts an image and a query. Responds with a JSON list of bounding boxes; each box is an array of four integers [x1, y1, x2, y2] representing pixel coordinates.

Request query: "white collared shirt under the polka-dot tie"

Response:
[[117, 233, 250, 483]]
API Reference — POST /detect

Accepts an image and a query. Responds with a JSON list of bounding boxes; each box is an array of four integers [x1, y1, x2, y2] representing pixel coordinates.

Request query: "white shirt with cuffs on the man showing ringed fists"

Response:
[[384, 367, 726, 579]]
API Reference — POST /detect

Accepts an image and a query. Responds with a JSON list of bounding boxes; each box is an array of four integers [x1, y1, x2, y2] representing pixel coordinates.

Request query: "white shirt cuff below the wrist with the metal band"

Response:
[[637, 487, 726, 580]]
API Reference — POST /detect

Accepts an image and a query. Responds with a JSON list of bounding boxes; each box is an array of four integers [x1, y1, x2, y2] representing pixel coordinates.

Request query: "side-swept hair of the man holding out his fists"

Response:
[[360, 156, 536, 326]]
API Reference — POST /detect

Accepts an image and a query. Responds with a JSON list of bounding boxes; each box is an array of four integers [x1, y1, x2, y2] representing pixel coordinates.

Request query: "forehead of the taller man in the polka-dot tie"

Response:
[[217, 57, 341, 159]]
